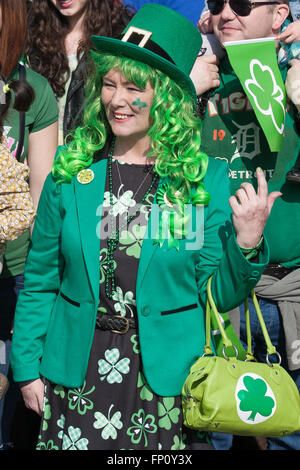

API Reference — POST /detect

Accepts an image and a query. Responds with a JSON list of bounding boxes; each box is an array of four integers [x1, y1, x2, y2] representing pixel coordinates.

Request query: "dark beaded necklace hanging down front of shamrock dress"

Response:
[[105, 140, 159, 299]]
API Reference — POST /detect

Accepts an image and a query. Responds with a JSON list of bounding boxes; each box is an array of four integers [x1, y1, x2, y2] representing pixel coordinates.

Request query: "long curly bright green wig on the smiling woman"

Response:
[[52, 52, 209, 206]]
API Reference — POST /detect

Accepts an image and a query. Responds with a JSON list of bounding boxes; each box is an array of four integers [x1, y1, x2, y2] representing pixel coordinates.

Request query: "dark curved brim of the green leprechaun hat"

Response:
[[91, 36, 197, 102]]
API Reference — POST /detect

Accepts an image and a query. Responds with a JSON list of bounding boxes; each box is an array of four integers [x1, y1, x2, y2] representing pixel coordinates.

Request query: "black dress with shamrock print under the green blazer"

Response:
[[37, 159, 212, 450]]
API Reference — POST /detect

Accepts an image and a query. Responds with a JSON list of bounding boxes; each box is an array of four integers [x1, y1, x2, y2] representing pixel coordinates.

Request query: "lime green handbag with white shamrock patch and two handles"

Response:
[[182, 278, 300, 437]]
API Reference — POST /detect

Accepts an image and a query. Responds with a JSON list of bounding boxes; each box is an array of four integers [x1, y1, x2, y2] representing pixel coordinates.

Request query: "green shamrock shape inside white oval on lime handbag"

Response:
[[237, 375, 275, 421]]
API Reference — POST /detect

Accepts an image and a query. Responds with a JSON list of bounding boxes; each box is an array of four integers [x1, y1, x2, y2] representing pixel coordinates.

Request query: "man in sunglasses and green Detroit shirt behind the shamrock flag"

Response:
[[192, 0, 300, 456]]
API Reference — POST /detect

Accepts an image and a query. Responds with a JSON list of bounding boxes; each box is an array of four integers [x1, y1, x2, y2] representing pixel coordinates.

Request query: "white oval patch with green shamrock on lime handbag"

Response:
[[235, 372, 276, 425]]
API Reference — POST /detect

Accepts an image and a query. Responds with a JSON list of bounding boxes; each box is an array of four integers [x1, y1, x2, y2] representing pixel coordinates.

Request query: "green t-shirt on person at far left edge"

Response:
[[1, 67, 58, 277]]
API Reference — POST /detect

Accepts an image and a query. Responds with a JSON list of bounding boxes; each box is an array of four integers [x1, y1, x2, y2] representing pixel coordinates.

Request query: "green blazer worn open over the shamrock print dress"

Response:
[[11, 152, 268, 396]]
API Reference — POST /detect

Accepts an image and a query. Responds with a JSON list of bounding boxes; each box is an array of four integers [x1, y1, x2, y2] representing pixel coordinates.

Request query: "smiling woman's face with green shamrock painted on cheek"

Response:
[[101, 69, 153, 143]]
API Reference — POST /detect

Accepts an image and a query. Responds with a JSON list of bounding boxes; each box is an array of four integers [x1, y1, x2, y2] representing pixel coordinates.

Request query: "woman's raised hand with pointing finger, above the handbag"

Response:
[[229, 168, 282, 248]]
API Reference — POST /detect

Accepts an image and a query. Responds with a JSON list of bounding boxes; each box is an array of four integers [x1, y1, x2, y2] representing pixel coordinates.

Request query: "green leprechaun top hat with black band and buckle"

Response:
[[91, 3, 202, 99]]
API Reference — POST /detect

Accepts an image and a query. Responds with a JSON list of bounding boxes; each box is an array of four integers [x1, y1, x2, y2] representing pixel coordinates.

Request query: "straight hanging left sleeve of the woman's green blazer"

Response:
[[10, 174, 64, 382]]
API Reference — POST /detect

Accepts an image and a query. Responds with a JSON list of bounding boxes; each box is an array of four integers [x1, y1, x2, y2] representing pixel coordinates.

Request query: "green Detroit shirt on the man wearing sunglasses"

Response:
[[202, 57, 300, 267]]
